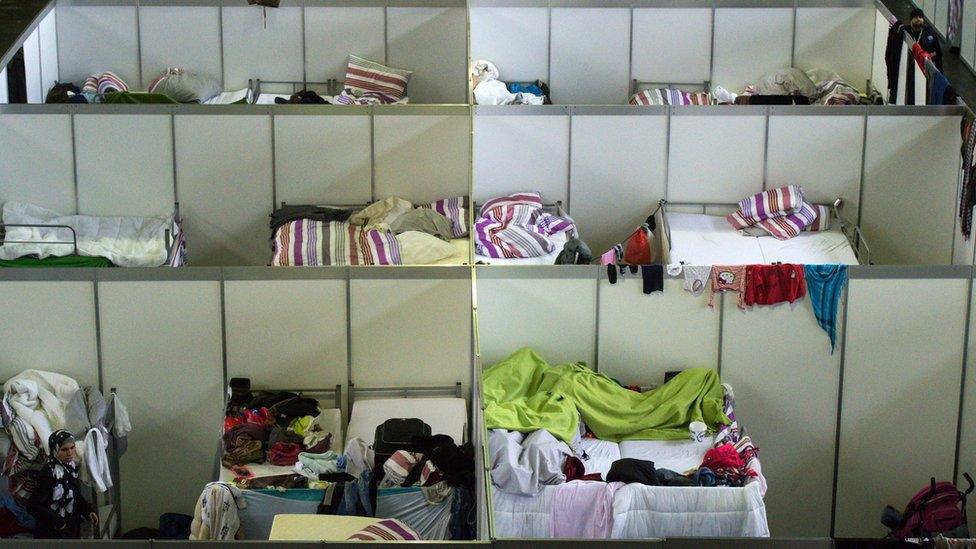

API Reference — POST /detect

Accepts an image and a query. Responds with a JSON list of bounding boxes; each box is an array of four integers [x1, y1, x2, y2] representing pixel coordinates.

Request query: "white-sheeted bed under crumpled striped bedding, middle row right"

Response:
[[658, 199, 871, 265]]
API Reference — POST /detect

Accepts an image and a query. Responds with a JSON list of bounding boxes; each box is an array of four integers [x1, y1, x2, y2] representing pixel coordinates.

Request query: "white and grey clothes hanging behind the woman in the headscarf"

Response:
[[0, 370, 132, 538]]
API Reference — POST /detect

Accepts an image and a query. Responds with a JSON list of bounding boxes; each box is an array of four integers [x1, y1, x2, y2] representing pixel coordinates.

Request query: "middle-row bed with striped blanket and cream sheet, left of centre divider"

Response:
[[270, 197, 471, 267]]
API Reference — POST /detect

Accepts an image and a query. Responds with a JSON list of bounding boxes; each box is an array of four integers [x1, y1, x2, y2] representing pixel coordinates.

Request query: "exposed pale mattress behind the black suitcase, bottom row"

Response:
[[346, 398, 468, 444]]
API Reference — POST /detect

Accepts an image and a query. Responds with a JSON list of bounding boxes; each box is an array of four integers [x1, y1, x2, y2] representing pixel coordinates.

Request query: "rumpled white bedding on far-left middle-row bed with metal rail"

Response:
[[0, 201, 173, 267]]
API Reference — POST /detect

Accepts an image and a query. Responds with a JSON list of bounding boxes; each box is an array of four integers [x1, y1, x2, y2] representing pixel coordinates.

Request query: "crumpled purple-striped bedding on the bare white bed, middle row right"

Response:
[[726, 185, 817, 240]]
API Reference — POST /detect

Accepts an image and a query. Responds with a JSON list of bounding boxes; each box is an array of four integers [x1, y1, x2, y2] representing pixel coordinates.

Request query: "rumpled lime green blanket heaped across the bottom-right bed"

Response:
[[482, 349, 730, 442]]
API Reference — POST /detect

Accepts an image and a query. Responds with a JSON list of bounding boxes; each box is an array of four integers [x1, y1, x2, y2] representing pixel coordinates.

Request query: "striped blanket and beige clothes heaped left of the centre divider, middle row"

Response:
[[270, 197, 468, 266]]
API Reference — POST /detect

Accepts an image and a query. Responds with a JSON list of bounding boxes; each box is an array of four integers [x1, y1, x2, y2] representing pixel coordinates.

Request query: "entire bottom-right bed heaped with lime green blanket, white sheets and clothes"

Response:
[[484, 349, 769, 539]]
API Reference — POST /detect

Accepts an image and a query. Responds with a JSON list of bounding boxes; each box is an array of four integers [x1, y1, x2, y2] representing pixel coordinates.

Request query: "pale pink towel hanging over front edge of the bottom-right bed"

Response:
[[549, 480, 623, 539]]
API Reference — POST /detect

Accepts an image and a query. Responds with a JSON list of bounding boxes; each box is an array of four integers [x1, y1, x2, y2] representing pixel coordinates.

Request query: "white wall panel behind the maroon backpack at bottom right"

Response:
[[834, 279, 969, 537]]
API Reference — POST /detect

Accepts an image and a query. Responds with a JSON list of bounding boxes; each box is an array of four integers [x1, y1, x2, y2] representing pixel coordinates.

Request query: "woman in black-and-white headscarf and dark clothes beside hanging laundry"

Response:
[[27, 429, 98, 539]]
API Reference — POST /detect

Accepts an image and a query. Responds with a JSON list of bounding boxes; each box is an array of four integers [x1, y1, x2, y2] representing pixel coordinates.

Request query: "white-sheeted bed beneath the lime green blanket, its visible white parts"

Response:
[[492, 385, 769, 539]]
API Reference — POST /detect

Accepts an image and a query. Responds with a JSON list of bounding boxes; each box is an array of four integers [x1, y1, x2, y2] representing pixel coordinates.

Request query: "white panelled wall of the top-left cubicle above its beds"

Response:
[[47, 0, 468, 104]]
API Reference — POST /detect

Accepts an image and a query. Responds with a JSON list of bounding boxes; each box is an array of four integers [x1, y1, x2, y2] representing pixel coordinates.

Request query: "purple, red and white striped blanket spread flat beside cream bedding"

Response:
[[271, 219, 402, 267]]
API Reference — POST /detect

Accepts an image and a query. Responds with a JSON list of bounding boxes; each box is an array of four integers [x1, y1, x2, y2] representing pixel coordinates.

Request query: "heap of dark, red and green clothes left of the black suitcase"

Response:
[[220, 384, 343, 488]]
